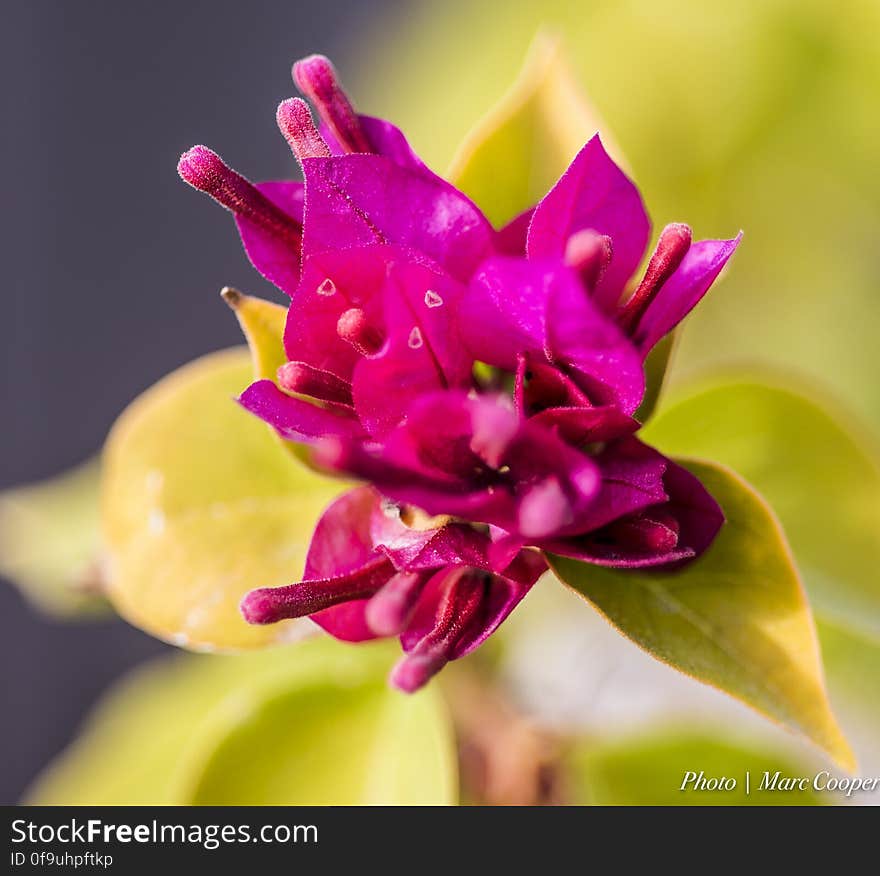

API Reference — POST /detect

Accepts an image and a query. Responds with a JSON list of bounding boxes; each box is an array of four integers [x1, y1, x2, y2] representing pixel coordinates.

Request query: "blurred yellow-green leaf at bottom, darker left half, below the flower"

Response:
[[181, 676, 455, 806]]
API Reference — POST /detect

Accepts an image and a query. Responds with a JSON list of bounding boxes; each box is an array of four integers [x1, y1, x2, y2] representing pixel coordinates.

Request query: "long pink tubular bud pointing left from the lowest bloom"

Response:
[[241, 557, 394, 624]]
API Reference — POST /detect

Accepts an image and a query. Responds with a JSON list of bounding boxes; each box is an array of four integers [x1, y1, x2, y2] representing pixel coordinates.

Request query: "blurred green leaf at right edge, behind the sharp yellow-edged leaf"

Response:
[[644, 380, 880, 636]]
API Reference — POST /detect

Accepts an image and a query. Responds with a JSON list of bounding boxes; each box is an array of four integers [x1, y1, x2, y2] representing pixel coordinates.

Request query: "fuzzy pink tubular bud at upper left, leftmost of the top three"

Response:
[[177, 146, 302, 246]]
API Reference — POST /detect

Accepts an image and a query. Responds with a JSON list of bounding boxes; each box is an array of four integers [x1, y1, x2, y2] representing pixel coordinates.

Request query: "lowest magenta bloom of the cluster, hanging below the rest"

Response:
[[242, 487, 546, 691]]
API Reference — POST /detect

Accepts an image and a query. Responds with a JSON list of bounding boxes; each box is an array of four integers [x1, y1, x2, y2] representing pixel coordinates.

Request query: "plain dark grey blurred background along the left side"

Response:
[[0, 0, 403, 803]]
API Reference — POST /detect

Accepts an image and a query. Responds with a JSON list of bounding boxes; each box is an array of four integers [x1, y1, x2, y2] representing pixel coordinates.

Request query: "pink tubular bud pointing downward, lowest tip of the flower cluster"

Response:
[[391, 569, 489, 693]]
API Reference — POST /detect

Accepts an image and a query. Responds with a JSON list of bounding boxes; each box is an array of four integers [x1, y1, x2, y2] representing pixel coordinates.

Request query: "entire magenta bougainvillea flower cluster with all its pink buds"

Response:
[[179, 56, 739, 690]]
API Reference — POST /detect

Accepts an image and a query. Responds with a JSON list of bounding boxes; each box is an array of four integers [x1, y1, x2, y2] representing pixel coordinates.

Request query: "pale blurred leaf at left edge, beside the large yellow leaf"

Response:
[[0, 461, 106, 617]]
